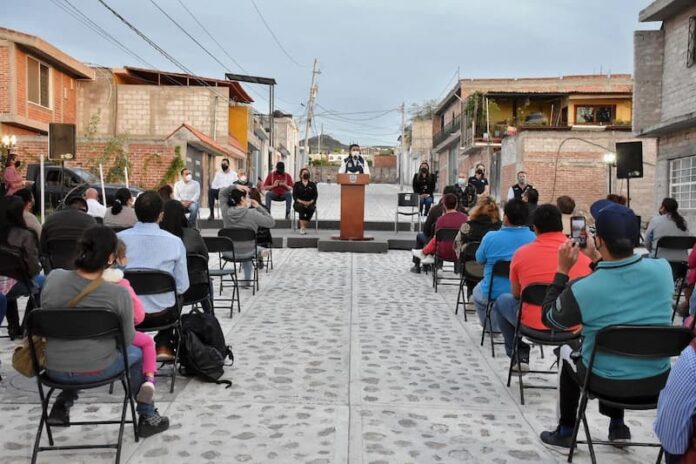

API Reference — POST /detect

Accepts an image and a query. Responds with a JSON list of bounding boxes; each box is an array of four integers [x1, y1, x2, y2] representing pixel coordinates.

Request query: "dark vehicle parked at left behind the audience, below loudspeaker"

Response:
[[27, 164, 143, 210]]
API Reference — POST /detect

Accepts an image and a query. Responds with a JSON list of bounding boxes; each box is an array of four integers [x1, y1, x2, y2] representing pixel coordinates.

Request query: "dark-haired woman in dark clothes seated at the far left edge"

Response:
[[0, 195, 45, 339]]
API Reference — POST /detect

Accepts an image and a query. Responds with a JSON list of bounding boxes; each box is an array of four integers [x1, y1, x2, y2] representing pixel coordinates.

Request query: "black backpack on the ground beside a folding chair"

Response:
[[179, 309, 234, 388]]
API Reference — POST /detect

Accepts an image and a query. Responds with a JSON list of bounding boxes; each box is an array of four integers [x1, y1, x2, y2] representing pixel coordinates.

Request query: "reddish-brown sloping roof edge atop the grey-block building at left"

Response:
[[114, 66, 254, 103]]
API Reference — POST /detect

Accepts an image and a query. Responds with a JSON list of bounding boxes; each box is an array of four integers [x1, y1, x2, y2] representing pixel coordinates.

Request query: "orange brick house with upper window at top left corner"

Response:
[[0, 28, 95, 167]]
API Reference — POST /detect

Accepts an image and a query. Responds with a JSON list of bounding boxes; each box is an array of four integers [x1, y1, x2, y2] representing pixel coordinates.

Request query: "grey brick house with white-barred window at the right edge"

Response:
[[633, 0, 696, 225]]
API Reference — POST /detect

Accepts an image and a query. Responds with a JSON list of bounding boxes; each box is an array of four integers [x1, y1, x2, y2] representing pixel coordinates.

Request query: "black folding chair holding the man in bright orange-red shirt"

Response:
[[507, 283, 580, 404]]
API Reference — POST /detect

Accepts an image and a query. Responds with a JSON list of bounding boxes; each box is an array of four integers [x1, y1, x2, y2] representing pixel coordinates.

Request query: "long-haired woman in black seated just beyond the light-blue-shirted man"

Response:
[[160, 200, 213, 312]]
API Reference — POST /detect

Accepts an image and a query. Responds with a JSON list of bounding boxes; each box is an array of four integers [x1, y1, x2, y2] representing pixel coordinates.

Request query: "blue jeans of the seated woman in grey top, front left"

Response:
[[47, 345, 155, 417]]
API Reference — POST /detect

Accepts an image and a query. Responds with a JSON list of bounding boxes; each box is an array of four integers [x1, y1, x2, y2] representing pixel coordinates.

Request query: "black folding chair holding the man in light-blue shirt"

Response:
[[124, 269, 181, 393]]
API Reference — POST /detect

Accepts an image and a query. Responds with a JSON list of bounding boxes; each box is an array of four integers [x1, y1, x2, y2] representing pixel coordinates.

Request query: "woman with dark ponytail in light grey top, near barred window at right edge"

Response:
[[645, 198, 689, 262]]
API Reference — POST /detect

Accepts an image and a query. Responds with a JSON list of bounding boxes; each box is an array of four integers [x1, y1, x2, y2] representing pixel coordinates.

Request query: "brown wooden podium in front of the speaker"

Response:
[[333, 173, 372, 240]]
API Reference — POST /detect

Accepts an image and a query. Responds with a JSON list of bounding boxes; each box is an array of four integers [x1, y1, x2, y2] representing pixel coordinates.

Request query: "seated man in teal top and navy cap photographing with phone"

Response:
[[541, 200, 674, 448]]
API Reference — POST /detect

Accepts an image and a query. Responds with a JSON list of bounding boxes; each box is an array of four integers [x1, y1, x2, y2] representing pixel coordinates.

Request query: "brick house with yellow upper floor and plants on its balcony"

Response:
[[433, 74, 655, 217]]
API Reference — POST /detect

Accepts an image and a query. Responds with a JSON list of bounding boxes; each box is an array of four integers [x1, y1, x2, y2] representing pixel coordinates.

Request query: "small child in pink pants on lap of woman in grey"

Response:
[[102, 240, 157, 403]]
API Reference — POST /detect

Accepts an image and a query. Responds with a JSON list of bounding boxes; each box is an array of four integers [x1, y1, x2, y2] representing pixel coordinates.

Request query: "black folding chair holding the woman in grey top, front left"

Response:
[[27, 308, 138, 464]]
